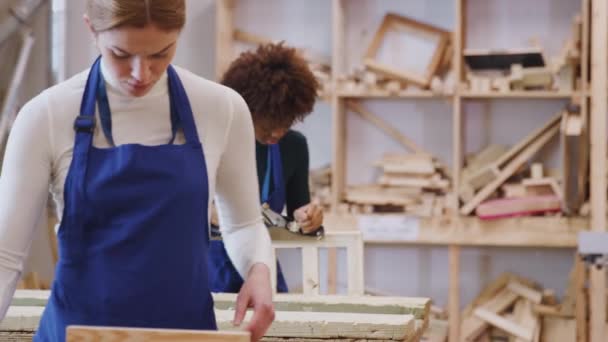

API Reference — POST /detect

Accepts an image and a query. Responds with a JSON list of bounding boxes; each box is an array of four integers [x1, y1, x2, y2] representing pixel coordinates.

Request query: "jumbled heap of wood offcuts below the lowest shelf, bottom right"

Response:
[[460, 274, 576, 342]]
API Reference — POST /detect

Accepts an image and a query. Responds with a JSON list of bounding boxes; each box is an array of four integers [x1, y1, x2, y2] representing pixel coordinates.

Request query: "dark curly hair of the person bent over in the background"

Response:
[[221, 42, 319, 127]]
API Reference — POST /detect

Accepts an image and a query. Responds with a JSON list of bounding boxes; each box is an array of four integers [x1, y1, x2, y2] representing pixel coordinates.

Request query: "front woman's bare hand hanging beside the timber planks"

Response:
[[234, 263, 274, 341]]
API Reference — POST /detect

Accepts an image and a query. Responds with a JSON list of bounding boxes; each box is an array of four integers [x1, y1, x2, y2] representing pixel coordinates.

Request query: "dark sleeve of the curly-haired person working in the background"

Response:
[[285, 134, 310, 218]]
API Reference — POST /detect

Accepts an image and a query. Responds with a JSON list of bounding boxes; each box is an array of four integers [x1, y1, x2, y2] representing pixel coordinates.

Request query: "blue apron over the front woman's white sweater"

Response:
[[34, 59, 216, 341]]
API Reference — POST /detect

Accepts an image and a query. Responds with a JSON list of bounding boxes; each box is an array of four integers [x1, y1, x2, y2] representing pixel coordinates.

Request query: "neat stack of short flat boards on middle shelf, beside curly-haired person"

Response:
[[346, 153, 450, 217]]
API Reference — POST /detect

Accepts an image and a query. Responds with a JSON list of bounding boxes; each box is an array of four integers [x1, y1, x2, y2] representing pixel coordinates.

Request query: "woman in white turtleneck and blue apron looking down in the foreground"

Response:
[[0, 0, 274, 341]]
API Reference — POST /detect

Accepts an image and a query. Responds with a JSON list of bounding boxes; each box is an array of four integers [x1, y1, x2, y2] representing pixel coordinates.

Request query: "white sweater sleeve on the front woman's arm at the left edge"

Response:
[[0, 95, 51, 319]]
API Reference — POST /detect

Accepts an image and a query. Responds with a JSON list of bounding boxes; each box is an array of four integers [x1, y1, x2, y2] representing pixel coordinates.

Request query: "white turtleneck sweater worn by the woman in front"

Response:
[[0, 63, 272, 320]]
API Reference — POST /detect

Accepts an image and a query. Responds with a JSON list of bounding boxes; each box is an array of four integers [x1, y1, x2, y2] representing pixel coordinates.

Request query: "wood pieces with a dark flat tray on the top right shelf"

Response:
[[464, 14, 582, 93]]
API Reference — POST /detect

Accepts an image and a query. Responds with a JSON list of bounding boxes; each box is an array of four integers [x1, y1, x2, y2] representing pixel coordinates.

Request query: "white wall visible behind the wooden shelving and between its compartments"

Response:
[[55, 0, 580, 305]]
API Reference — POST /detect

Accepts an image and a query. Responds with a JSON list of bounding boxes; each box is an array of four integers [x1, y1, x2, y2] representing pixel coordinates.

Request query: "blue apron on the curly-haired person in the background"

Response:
[[209, 144, 289, 293]]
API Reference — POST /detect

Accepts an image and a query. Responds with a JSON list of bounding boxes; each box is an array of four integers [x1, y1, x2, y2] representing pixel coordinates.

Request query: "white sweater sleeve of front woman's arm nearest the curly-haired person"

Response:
[[216, 89, 272, 279]]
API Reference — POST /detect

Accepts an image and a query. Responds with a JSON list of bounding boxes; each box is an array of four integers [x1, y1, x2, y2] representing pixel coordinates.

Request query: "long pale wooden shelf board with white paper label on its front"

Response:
[[324, 215, 590, 248]]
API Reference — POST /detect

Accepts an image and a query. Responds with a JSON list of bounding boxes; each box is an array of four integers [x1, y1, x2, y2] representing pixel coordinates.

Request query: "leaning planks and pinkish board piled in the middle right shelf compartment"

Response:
[[458, 103, 589, 219]]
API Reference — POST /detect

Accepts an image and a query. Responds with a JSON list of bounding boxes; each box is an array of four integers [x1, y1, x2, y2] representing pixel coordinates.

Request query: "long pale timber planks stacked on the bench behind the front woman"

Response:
[[0, 291, 430, 342]]
